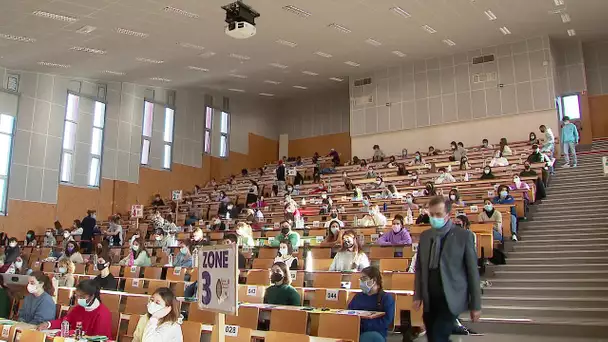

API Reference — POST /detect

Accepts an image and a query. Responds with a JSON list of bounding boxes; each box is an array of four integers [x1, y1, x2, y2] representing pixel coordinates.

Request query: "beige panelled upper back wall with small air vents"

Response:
[[350, 37, 555, 138]]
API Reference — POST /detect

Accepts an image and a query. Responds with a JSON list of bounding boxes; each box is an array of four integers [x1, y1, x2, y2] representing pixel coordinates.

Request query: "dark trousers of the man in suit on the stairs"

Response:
[[422, 297, 456, 342]]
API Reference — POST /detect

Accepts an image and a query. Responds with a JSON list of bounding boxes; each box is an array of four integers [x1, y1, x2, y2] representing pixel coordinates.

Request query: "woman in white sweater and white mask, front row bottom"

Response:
[[133, 287, 184, 342]]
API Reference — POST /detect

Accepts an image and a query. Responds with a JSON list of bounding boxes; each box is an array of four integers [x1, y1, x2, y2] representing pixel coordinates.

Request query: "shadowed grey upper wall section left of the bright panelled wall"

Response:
[[277, 84, 350, 140]]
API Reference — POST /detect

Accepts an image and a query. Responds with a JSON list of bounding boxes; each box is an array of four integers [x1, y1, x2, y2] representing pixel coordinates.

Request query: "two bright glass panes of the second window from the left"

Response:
[[59, 93, 106, 187]]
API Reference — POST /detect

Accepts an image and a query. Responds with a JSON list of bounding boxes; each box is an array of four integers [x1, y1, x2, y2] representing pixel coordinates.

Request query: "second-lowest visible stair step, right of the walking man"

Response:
[[482, 302, 608, 320]]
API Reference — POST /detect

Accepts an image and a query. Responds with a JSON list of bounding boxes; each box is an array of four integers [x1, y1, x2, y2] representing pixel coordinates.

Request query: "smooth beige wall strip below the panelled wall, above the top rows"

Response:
[[351, 109, 559, 158]]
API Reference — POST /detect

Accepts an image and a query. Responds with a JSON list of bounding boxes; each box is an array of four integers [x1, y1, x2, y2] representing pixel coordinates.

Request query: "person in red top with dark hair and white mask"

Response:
[[38, 279, 113, 339]]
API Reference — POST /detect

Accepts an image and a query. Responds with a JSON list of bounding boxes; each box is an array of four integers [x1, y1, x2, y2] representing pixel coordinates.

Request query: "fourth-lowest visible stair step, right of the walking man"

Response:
[[483, 285, 608, 298]]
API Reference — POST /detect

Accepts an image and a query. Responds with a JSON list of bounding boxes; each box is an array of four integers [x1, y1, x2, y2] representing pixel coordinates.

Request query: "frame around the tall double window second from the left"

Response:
[[59, 89, 108, 189]]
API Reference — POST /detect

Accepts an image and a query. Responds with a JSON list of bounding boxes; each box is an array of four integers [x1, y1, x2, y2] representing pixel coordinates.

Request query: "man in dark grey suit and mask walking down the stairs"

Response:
[[414, 196, 481, 342]]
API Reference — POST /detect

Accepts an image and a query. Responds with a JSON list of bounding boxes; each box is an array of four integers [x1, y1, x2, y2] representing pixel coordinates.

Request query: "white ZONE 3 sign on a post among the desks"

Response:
[[197, 245, 239, 315]]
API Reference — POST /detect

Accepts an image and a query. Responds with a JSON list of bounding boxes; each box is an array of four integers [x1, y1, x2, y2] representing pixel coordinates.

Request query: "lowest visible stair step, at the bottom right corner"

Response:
[[459, 316, 608, 336]]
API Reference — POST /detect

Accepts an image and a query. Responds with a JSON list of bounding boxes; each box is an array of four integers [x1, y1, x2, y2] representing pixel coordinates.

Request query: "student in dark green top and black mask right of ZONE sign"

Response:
[[264, 262, 302, 305]]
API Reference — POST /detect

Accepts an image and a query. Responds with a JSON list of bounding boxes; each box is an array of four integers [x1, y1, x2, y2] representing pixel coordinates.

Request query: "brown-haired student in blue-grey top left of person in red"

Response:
[[18, 271, 55, 325]]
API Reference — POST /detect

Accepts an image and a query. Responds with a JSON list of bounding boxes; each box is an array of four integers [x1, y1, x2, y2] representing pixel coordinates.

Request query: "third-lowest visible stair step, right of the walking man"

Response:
[[482, 294, 608, 308]]
